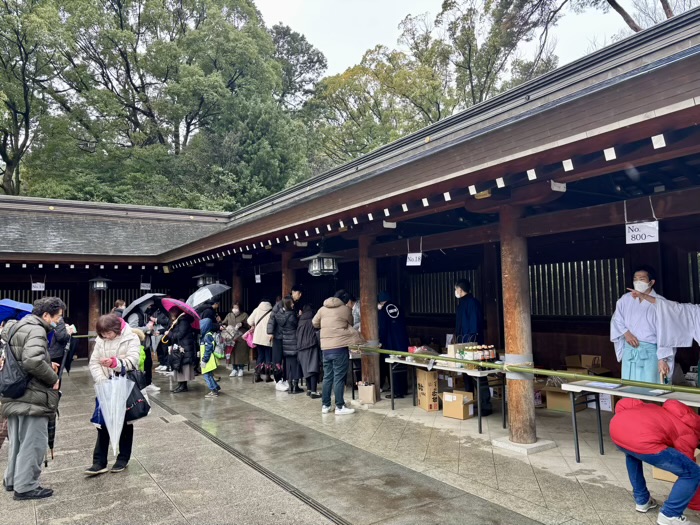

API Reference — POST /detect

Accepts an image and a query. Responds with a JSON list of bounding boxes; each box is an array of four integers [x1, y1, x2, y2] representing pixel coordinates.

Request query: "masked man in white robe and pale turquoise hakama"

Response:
[[610, 267, 675, 383]]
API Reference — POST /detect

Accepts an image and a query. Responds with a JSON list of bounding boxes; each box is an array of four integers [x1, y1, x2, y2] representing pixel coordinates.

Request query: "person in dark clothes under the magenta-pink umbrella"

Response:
[[161, 298, 199, 394]]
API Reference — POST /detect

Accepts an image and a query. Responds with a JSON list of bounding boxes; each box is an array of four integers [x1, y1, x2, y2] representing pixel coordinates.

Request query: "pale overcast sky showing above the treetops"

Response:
[[255, 0, 628, 75]]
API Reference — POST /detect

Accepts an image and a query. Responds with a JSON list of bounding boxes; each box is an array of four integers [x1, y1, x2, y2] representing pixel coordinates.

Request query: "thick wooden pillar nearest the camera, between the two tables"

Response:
[[500, 206, 537, 444]]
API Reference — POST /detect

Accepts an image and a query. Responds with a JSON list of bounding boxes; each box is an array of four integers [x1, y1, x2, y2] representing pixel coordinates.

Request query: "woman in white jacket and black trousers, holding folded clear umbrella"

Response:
[[85, 314, 141, 476]]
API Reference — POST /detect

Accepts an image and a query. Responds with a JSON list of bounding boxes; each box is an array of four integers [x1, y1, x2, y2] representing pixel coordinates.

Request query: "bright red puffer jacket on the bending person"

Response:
[[610, 399, 700, 460]]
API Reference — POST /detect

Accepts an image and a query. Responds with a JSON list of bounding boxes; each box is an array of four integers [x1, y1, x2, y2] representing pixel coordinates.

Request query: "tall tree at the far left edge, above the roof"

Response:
[[0, 0, 58, 195]]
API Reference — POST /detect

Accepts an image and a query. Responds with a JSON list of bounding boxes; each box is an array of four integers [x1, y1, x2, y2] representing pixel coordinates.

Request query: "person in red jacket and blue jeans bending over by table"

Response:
[[610, 399, 700, 525]]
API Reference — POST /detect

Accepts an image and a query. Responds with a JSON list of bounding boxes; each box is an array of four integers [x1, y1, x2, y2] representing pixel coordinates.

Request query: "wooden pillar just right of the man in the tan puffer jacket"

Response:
[[358, 236, 381, 399]]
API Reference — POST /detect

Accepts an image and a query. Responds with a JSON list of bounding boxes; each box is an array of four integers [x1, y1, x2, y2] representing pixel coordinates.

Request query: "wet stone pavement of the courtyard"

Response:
[[0, 368, 693, 525]]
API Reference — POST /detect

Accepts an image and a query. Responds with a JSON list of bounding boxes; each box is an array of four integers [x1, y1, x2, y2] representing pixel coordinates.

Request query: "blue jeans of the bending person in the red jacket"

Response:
[[618, 447, 700, 518]]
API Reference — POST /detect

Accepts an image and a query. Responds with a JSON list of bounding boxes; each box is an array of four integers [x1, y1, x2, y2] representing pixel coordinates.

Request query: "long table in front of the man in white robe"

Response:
[[561, 381, 700, 463]]
